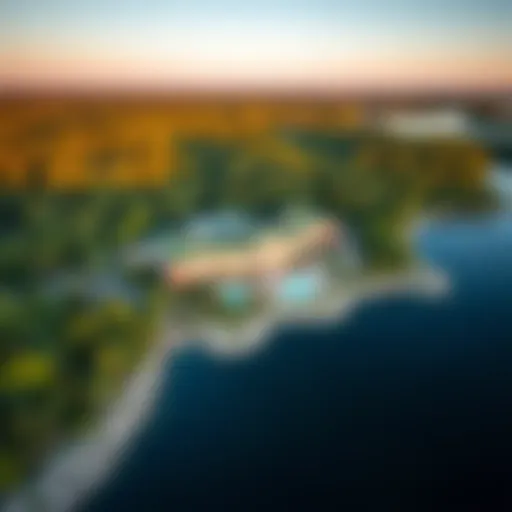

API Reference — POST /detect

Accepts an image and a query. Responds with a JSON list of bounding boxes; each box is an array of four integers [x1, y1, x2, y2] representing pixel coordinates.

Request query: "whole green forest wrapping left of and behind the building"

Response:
[[0, 129, 493, 490]]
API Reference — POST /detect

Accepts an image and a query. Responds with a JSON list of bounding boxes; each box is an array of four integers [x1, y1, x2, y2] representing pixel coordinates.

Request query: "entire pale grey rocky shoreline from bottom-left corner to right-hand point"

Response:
[[4, 266, 449, 512]]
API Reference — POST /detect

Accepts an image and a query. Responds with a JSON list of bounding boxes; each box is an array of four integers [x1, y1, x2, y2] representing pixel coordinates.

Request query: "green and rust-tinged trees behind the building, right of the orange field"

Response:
[[175, 132, 492, 268]]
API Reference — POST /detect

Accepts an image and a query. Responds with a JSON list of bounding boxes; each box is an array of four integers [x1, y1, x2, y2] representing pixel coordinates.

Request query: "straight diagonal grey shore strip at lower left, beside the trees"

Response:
[[3, 324, 181, 512]]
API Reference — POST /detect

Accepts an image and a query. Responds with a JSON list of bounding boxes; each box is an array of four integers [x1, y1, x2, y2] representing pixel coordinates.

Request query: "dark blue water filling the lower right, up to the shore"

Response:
[[80, 213, 512, 512]]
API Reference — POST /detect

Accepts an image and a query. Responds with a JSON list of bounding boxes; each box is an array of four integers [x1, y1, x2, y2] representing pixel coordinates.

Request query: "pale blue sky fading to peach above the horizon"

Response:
[[0, 0, 512, 92]]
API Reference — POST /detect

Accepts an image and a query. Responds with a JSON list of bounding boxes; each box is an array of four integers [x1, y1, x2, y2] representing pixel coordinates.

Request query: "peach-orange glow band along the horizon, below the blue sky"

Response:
[[0, 52, 512, 92]]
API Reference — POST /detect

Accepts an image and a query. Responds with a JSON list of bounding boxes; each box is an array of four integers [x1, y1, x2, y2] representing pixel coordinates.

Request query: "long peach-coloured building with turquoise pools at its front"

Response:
[[166, 213, 341, 309]]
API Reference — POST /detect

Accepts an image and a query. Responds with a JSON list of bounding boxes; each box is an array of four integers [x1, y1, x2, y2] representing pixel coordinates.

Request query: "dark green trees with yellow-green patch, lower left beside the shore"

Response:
[[0, 282, 165, 491]]
